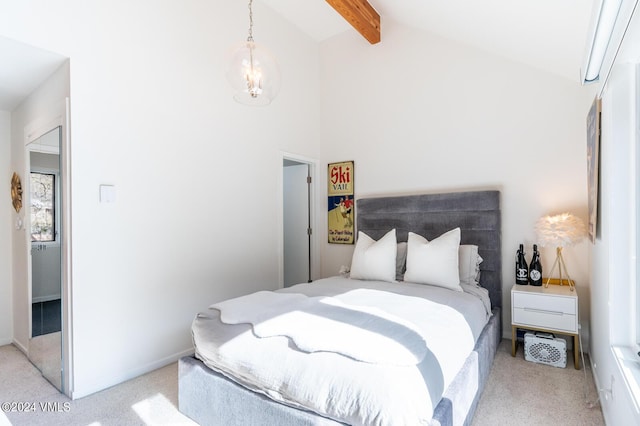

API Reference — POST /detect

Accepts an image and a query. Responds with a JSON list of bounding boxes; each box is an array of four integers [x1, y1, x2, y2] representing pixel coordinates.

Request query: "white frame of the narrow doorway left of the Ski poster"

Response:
[[277, 151, 320, 288]]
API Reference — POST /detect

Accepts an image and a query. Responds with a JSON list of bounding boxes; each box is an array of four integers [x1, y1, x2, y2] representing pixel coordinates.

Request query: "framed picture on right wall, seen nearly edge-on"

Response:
[[587, 97, 602, 243]]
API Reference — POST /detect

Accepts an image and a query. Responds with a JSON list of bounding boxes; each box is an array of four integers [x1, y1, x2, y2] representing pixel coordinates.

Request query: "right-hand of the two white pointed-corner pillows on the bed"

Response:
[[404, 228, 462, 291]]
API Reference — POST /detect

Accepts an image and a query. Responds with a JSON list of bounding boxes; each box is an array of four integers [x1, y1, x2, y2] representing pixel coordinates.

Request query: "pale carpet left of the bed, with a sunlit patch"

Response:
[[0, 345, 195, 426]]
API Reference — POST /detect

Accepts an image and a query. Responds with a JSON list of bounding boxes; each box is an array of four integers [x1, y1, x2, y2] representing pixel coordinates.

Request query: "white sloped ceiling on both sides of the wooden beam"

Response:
[[256, 0, 594, 82]]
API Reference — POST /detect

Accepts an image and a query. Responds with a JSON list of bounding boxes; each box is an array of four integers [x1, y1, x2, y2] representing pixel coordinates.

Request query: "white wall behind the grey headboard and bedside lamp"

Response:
[[321, 20, 589, 342]]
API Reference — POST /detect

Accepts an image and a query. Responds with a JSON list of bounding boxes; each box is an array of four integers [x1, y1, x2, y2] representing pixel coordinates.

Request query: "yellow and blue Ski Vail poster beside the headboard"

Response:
[[327, 161, 356, 244]]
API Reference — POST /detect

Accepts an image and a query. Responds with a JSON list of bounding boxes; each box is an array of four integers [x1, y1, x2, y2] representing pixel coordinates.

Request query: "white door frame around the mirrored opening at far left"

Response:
[[23, 97, 73, 397]]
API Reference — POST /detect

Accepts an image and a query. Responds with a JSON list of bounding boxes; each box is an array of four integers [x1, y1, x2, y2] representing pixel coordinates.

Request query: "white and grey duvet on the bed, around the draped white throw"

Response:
[[192, 277, 488, 425]]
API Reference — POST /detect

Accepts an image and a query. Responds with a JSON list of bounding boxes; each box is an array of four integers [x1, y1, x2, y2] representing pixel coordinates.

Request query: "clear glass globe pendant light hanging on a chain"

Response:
[[227, 0, 280, 106]]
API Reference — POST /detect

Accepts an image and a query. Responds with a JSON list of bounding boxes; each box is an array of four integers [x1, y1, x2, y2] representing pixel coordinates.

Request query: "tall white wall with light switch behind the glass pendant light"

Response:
[[0, 0, 319, 397]]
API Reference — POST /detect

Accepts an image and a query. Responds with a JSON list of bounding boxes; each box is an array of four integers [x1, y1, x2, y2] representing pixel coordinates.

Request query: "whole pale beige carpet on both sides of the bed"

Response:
[[0, 340, 604, 426]]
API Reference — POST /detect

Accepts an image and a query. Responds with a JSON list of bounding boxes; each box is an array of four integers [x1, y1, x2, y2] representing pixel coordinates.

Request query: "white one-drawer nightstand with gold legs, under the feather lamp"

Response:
[[511, 284, 580, 370]]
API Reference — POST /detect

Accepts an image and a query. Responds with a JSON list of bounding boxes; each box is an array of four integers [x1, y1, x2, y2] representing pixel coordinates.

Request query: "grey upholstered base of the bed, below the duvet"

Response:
[[178, 308, 502, 426]]
